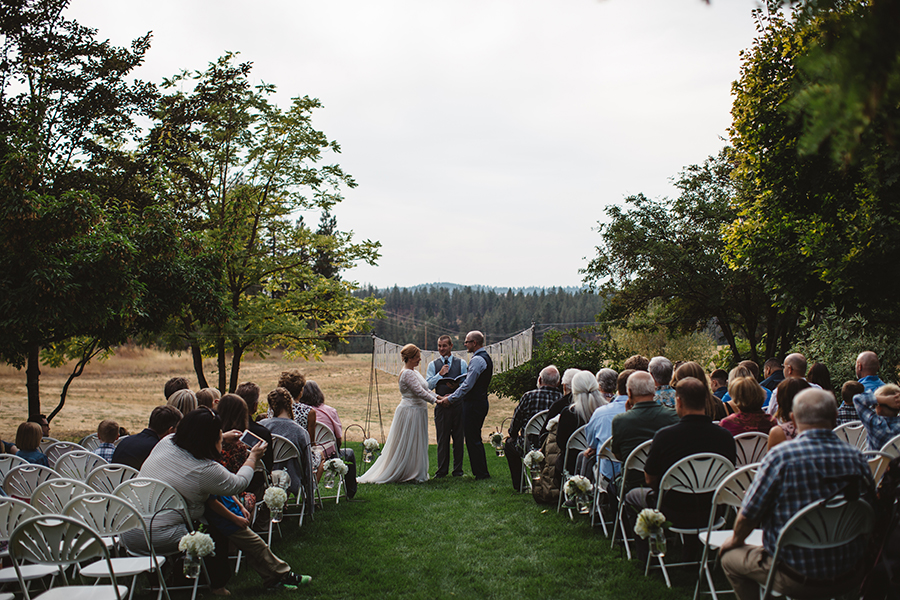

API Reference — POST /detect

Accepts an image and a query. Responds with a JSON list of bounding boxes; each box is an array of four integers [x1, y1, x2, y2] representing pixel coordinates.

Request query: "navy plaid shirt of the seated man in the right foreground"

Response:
[[741, 429, 874, 579]]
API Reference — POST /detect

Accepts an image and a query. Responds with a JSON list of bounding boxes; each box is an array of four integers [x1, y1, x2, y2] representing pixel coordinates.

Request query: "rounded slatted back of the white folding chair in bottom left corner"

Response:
[[9, 515, 127, 600]]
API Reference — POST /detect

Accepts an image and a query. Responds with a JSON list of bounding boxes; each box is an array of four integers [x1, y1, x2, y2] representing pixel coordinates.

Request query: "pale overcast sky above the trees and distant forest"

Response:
[[68, 0, 757, 287]]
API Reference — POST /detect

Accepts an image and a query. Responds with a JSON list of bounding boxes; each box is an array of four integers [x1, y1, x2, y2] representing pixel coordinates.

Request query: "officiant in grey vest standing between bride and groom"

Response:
[[425, 335, 468, 477]]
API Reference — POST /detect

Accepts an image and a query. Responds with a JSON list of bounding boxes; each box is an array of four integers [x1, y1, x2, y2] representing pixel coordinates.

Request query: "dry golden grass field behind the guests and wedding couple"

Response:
[[0, 347, 515, 444]]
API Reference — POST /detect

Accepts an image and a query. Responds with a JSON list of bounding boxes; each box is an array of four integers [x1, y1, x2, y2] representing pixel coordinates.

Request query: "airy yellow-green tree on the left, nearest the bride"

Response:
[[145, 54, 379, 390]]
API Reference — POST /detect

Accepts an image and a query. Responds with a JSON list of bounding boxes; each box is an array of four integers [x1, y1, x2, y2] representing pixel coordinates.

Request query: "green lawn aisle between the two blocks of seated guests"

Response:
[[223, 446, 696, 600]]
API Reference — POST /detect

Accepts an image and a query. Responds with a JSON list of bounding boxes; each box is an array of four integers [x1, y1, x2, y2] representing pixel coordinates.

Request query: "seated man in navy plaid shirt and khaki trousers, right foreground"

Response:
[[720, 389, 874, 600]]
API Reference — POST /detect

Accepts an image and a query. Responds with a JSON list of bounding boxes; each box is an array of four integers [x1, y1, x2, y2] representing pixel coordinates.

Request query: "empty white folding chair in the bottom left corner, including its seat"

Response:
[[9, 515, 128, 600]]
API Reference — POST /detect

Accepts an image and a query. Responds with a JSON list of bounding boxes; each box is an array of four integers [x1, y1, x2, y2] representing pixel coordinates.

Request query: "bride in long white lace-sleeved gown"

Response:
[[358, 344, 437, 483]]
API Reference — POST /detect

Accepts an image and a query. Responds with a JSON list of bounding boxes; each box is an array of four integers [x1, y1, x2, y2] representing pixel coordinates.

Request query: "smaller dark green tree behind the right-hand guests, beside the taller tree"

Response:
[[582, 149, 796, 361]]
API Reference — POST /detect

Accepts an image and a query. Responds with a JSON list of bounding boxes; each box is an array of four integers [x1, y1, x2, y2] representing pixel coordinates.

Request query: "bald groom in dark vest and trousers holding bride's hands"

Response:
[[438, 331, 494, 479]]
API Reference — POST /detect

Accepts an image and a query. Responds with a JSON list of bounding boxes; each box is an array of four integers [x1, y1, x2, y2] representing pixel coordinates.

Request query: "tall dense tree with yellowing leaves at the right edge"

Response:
[[726, 2, 900, 320]]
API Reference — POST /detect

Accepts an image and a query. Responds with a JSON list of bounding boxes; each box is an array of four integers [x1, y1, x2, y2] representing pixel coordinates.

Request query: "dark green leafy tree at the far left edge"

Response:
[[0, 0, 197, 418]]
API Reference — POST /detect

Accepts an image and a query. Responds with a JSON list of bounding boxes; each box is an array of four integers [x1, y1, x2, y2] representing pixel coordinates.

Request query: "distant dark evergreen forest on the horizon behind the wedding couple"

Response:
[[337, 285, 603, 352]]
